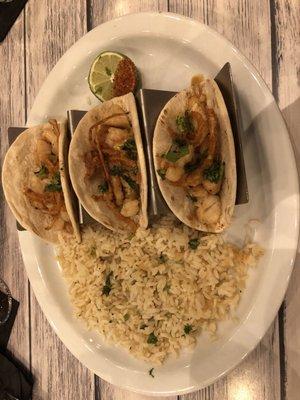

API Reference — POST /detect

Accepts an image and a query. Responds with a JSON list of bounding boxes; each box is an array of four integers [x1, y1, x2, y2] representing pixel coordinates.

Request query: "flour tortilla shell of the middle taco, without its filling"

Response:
[[69, 93, 148, 231]]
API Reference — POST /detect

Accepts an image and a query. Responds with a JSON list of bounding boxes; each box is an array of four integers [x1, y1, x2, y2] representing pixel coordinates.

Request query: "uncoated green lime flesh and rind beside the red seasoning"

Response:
[[88, 51, 126, 101]]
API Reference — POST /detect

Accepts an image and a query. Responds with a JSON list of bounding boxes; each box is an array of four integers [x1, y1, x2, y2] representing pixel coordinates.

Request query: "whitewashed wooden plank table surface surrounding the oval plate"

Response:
[[0, 0, 300, 400]]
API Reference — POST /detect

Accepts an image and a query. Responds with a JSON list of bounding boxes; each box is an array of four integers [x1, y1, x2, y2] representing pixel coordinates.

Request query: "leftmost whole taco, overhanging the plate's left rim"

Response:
[[2, 120, 80, 243]]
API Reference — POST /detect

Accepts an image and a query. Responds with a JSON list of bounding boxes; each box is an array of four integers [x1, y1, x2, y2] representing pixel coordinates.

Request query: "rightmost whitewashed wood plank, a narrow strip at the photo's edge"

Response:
[[274, 0, 300, 400]]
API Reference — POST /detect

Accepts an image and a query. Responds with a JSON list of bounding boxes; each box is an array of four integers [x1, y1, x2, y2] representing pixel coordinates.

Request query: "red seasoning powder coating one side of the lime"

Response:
[[113, 57, 137, 96]]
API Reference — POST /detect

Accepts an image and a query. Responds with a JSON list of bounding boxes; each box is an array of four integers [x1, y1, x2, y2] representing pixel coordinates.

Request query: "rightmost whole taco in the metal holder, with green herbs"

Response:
[[153, 75, 236, 232]]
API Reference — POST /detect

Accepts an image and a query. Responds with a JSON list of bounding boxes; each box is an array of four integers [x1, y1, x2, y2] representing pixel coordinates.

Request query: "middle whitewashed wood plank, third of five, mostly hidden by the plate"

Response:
[[89, 0, 173, 400]]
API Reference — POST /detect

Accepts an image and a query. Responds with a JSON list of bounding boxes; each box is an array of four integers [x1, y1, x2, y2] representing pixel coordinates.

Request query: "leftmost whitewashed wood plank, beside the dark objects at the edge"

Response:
[[0, 13, 30, 368]]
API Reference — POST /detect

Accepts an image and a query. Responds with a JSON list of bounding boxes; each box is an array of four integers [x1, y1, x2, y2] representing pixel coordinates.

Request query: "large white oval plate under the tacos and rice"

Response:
[[20, 13, 299, 395]]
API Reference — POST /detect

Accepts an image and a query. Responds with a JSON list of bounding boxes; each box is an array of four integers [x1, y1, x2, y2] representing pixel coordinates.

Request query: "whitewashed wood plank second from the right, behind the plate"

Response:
[[169, 0, 280, 400]]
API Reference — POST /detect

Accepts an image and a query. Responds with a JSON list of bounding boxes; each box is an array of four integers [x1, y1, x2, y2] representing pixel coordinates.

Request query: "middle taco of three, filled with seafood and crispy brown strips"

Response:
[[69, 93, 148, 231]]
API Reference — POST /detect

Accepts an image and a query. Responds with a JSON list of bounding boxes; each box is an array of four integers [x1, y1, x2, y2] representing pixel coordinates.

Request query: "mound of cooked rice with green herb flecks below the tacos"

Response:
[[58, 217, 263, 363]]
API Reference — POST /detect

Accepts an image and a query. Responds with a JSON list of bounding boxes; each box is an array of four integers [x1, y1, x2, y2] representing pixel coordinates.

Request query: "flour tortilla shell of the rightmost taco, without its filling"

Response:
[[153, 75, 236, 233]]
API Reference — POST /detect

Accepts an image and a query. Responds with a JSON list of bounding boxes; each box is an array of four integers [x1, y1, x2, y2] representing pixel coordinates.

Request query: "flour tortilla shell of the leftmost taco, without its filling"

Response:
[[2, 123, 81, 244]]
